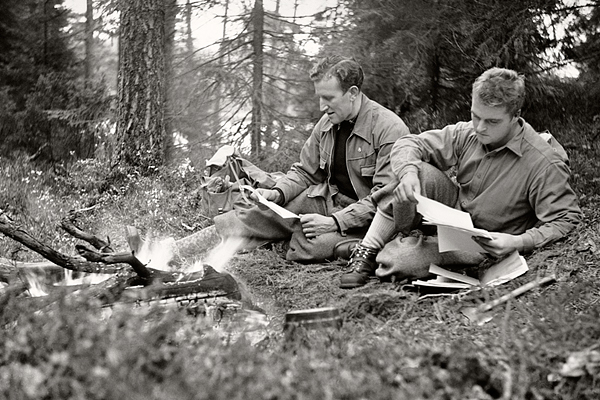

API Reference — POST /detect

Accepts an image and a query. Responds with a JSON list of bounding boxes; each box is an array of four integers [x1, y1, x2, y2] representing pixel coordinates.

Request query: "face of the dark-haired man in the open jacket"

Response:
[[315, 77, 356, 125]]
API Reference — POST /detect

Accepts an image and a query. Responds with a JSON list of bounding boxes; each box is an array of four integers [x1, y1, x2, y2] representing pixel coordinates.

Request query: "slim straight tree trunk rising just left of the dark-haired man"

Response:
[[251, 0, 264, 157]]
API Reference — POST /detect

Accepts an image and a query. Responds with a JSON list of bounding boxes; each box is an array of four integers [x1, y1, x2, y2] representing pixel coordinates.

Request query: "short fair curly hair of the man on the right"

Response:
[[472, 68, 525, 116]]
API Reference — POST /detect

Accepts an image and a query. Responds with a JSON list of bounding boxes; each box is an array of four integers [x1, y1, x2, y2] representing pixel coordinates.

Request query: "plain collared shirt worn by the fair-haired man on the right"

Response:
[[391, 119, 582, 250]]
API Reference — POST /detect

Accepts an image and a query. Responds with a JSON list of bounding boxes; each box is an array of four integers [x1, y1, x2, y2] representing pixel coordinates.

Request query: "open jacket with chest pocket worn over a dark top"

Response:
[[274, 93, 409, 232]]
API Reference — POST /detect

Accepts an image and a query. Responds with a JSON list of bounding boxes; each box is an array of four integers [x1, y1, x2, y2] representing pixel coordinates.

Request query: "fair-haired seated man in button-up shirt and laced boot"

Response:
[[340, 68, 582, 288]]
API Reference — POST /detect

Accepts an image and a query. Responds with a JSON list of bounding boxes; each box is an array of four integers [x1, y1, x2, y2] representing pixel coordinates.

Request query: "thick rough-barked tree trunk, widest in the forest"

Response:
[[117, 0, 166, 174]]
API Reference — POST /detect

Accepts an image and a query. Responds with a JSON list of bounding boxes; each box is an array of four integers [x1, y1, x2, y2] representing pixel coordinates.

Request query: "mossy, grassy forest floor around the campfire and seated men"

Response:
[[0, 123, 600, 400]]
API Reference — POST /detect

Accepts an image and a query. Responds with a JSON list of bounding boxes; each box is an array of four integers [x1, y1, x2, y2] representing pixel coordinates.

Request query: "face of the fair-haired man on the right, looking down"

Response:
[[471, 95, 518, 150]]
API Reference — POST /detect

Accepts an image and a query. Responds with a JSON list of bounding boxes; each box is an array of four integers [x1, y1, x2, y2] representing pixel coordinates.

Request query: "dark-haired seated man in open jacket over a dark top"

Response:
[[214, 56, 409, 262]]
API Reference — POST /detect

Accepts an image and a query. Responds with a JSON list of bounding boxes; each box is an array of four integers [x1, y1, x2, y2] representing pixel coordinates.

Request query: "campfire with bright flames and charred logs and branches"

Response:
[[0, 212, 243, 305]]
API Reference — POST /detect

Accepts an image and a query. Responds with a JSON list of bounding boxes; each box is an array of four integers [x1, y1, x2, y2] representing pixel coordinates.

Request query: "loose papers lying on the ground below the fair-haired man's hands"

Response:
[[413, 251, 529, 289]]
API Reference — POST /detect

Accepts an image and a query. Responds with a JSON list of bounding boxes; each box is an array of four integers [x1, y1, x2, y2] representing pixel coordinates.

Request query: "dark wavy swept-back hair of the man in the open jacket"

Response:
[[310, 55, 365, 93]]
